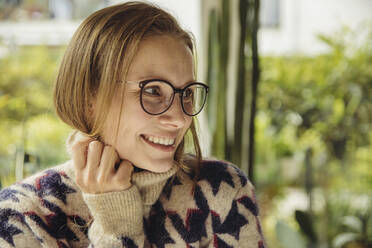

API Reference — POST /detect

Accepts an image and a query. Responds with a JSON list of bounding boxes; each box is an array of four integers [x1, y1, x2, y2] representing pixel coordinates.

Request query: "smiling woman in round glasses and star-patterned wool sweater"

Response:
[[0, 2, 264, 247]]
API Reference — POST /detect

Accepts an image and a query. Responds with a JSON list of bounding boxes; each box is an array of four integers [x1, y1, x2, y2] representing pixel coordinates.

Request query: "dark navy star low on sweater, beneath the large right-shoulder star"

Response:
[[211, 200, 248, 240]]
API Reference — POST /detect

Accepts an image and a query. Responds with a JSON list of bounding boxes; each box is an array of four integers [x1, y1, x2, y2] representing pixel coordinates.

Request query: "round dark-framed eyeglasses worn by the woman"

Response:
[[127, 79, 209, 116]]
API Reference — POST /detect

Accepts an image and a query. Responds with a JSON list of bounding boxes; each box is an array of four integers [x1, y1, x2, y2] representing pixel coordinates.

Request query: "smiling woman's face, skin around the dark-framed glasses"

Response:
[[102, 36, 195, 172]]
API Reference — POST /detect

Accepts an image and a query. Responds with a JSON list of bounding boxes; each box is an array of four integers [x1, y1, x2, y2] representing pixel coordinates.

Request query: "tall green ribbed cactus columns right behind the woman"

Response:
[[203, 0, 259, 180]]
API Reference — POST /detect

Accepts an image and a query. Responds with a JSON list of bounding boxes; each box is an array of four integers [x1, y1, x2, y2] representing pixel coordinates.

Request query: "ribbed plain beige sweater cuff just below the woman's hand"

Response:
[[83, 185, 143, 235]]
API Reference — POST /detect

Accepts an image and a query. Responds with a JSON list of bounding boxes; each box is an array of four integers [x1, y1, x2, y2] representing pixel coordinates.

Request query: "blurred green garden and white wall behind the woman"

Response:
[[0, 0, 372, 248]]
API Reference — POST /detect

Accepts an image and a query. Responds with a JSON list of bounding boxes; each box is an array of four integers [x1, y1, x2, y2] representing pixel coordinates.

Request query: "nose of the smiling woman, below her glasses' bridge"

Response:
[[160, 94, 191, 128]]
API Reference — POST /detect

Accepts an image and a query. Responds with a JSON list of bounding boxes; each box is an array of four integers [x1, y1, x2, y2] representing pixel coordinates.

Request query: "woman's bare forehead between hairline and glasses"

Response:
[[127, 36, 194, 86]]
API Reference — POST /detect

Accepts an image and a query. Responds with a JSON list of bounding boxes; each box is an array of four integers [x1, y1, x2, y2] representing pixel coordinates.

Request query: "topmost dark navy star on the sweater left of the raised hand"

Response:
[[22, 170, 76, 204]]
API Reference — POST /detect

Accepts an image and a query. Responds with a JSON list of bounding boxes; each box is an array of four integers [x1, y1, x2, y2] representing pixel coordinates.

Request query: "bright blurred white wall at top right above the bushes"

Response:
[[259, 0, 372, 55]]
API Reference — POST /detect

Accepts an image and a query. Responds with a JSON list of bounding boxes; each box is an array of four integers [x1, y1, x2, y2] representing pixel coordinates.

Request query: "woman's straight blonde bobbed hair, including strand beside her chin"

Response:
[[54, 2, 201, 178]]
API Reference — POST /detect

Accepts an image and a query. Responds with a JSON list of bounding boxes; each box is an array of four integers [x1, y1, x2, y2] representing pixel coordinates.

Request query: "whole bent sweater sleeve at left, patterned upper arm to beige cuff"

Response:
[[0, 182, 145, 248]]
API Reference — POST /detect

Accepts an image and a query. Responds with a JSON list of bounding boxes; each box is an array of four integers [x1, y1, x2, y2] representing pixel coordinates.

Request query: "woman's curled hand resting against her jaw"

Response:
[[71, 136, 133, 194]]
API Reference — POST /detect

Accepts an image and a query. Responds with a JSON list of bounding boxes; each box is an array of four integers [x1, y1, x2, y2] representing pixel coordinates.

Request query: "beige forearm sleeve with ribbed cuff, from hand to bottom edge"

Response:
[[83, 185, 145, 248]]
